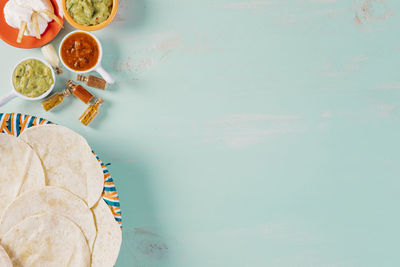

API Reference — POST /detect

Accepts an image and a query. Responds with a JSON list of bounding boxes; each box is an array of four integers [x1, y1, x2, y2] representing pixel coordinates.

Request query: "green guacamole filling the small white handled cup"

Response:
[[13, 59, 54, 98]]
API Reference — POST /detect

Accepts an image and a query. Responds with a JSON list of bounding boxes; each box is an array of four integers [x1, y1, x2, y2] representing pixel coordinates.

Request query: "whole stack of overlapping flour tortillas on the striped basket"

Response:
[[0, 125, 122, 267]]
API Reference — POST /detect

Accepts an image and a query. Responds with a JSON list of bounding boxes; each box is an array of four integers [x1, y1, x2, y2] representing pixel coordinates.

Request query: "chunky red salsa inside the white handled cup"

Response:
[[61, 32, 100, 71]]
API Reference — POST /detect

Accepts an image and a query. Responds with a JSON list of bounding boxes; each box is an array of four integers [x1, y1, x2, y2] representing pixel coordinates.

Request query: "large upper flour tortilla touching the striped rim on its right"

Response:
[[19, 125, 104, 208]]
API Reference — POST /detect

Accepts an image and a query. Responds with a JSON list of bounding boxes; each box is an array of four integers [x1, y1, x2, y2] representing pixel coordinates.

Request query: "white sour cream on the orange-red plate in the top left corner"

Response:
[[4, 0, 54, 36]]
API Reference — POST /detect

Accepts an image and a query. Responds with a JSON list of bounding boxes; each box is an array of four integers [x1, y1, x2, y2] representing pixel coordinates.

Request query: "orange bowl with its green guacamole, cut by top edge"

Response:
[[63, 0, 118, 31]]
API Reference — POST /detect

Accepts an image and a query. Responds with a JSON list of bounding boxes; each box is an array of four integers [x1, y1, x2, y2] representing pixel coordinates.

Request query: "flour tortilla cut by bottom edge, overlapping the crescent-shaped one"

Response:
[[1, 214, 90, 267]]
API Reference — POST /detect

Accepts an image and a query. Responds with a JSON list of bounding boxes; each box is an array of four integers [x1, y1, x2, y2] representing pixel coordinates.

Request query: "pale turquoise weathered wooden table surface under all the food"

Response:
[[0, 0, 400, 267]]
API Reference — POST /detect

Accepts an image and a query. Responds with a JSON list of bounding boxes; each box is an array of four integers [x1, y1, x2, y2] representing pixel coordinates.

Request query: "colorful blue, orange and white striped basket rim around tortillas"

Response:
[[0, 113, 122, 229]]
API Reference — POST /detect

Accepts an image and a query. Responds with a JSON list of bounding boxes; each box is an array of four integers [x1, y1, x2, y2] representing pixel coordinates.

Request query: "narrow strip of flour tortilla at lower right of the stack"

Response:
[[92, 199, 122, 267]]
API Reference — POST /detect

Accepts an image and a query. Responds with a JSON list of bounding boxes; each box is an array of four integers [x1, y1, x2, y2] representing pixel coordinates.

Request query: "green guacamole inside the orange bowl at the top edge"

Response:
[[66, 0, 113, 26]]
